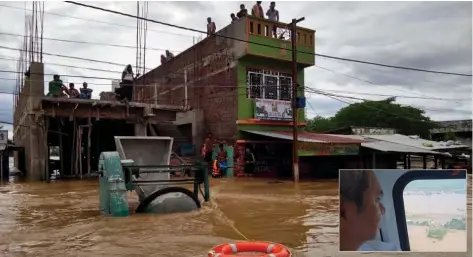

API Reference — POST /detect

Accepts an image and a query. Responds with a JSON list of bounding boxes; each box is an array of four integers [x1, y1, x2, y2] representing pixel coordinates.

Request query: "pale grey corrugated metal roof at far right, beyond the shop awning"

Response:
[[364, 134, 468, 151]]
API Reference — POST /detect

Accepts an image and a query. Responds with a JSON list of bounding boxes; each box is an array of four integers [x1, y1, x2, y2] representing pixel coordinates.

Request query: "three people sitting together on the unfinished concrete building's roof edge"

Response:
[[47, 74, 93, 99]]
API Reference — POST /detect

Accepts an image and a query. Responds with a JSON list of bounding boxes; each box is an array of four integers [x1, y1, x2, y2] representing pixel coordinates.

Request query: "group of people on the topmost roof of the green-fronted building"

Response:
[[207, 1, 279, 37]]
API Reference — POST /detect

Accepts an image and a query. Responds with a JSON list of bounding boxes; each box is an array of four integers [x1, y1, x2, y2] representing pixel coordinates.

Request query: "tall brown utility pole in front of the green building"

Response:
[[290, 17, 305, 183]]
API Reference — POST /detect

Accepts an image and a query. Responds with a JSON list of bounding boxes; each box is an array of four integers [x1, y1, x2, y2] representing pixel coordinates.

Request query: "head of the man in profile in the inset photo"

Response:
[[339, 170, 385, 251]]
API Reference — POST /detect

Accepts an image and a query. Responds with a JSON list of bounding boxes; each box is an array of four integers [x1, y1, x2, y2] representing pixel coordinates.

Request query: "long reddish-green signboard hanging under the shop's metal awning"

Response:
[[298, 142, 360, 156]]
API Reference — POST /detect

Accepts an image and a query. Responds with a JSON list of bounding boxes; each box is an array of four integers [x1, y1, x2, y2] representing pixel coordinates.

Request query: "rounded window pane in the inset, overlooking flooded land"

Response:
[[403, 179, 467, 252]]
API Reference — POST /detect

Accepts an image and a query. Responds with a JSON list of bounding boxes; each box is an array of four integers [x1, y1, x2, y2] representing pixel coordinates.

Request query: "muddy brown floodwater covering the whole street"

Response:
[[0, 178, 471, 257]]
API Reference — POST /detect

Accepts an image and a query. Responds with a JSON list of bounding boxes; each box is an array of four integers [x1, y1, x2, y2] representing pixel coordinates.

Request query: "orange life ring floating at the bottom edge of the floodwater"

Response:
[[208, 241, 291, 257]]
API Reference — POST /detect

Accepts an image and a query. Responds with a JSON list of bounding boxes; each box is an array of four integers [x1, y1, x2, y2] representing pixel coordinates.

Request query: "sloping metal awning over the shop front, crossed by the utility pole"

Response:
[[243, 130, 363, 144]]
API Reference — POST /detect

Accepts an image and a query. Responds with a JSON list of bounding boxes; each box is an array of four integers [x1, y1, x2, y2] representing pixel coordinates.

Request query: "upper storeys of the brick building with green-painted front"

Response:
[[134, 17, 315, 143]]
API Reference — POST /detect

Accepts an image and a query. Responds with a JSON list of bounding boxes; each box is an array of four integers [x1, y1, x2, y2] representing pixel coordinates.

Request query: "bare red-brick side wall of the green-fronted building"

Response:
[[133, 33, 237, 142]]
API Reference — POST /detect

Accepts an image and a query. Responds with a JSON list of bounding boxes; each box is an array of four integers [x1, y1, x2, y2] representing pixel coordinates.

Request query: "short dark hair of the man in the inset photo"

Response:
[[339, 170, 371, 211]]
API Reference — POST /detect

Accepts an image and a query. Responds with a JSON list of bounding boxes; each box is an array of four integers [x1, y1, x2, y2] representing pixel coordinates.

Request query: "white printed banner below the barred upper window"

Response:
[[255, 98, 292, 121]]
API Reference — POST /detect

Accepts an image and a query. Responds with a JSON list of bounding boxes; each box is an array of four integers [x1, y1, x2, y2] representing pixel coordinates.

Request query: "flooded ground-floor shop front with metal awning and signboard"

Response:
[[235, 130, 362, 179]]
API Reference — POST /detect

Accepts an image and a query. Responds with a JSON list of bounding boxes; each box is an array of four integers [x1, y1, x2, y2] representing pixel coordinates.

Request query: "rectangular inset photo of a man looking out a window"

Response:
[[339, 169, 467, 252]]
